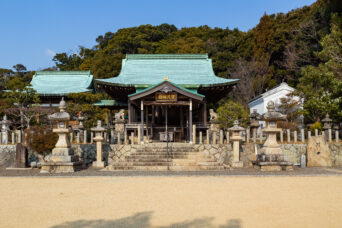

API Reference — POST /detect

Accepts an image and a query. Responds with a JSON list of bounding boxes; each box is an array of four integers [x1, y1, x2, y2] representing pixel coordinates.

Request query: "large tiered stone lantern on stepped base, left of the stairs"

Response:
[[41, 98, 81, 173]]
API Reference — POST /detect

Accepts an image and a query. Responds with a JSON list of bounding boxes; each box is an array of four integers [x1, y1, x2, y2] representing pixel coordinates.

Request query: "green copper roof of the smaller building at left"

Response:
[[31, 71, 94, 96]]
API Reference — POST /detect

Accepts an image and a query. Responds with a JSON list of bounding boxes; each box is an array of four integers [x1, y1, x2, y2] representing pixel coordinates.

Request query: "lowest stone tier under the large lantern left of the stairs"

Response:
[[40, 161, 82, 173]]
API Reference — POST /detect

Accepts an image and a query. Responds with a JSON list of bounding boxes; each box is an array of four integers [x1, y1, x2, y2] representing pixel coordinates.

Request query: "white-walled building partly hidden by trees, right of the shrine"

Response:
[[248, 82, 300, 126]]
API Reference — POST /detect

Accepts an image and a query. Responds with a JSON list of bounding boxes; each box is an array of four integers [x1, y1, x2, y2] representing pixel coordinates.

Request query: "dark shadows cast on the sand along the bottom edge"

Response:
[[51, 212, 242, 228]]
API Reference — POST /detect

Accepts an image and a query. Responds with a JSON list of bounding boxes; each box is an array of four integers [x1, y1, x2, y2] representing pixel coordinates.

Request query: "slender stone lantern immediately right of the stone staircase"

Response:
[[228, 120, 245, 168]]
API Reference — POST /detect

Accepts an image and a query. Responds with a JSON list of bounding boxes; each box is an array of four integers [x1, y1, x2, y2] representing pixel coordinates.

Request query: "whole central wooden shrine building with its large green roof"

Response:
[[95, 54, 238, 142]]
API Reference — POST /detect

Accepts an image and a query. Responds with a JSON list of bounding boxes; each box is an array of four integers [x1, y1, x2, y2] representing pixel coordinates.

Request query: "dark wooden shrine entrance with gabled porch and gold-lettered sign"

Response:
[[125, 81, 207, 142]]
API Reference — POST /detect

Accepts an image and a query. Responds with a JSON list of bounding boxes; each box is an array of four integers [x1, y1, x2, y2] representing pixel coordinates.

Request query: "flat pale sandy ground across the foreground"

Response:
[[0, 176, 342, 228]]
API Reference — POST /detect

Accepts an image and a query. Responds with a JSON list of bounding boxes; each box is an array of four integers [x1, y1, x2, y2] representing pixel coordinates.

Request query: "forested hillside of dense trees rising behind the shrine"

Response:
[[0, 0, 342, 122]]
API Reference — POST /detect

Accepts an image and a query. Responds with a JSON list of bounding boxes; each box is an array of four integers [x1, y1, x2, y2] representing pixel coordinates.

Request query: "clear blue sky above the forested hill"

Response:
[[0, 0, 315, 70]]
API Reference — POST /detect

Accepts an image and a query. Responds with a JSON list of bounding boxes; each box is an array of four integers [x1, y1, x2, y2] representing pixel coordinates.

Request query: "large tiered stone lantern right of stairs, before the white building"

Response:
[[255, 101, 293, 171]]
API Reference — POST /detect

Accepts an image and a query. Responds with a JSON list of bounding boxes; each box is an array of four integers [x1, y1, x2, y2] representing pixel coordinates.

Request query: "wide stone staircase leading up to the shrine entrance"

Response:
[[107, 143, 224, 171]]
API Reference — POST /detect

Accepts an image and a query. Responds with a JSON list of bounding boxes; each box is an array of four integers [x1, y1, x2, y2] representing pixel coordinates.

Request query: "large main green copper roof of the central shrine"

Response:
[[96, 54, 238, 88]]
